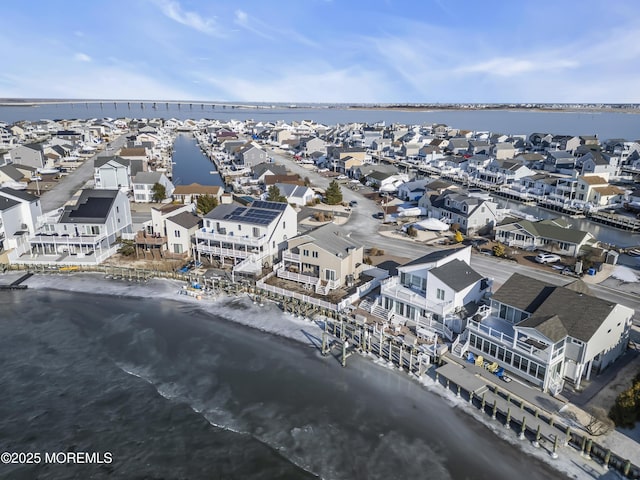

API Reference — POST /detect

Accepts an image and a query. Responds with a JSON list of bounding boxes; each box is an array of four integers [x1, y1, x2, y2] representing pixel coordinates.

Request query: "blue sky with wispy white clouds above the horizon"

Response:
[[0, 0, 640, 103]]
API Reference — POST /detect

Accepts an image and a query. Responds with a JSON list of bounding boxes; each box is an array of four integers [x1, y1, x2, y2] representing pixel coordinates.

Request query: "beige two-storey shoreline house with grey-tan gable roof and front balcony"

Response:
[[276, 223, 363, 295]]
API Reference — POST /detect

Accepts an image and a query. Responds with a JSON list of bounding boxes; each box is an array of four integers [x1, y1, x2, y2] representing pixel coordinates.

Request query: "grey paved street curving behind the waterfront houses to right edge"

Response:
[[271, 150, 640, 316]]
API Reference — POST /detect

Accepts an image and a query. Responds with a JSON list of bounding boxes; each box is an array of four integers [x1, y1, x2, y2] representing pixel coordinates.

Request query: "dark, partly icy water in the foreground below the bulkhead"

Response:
[[0, 291, 562, 480]]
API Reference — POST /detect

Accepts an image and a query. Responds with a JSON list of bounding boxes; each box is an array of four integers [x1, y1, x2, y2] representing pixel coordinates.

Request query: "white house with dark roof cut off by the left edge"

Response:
[[0, 187, 42, 257]]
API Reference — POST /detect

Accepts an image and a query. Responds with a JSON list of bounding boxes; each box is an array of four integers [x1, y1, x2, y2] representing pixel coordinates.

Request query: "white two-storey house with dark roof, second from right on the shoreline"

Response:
[[373, 246, 490, 340]]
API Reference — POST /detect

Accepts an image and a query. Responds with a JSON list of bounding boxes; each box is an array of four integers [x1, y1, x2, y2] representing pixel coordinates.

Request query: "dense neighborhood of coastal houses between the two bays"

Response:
[[0, 112, 640, 404]]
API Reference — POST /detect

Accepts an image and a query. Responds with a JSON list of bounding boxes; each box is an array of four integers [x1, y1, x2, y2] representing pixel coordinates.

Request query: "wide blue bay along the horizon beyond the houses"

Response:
[[0, 102, 640, 140]]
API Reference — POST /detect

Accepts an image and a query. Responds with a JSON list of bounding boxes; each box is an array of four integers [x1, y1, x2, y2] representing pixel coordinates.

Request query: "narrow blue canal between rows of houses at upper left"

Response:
[[173, 133, 224, 187]]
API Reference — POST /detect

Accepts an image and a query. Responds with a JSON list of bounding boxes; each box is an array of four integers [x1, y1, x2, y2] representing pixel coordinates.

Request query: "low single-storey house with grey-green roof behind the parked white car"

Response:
[[495, 217, 597, 257]]
